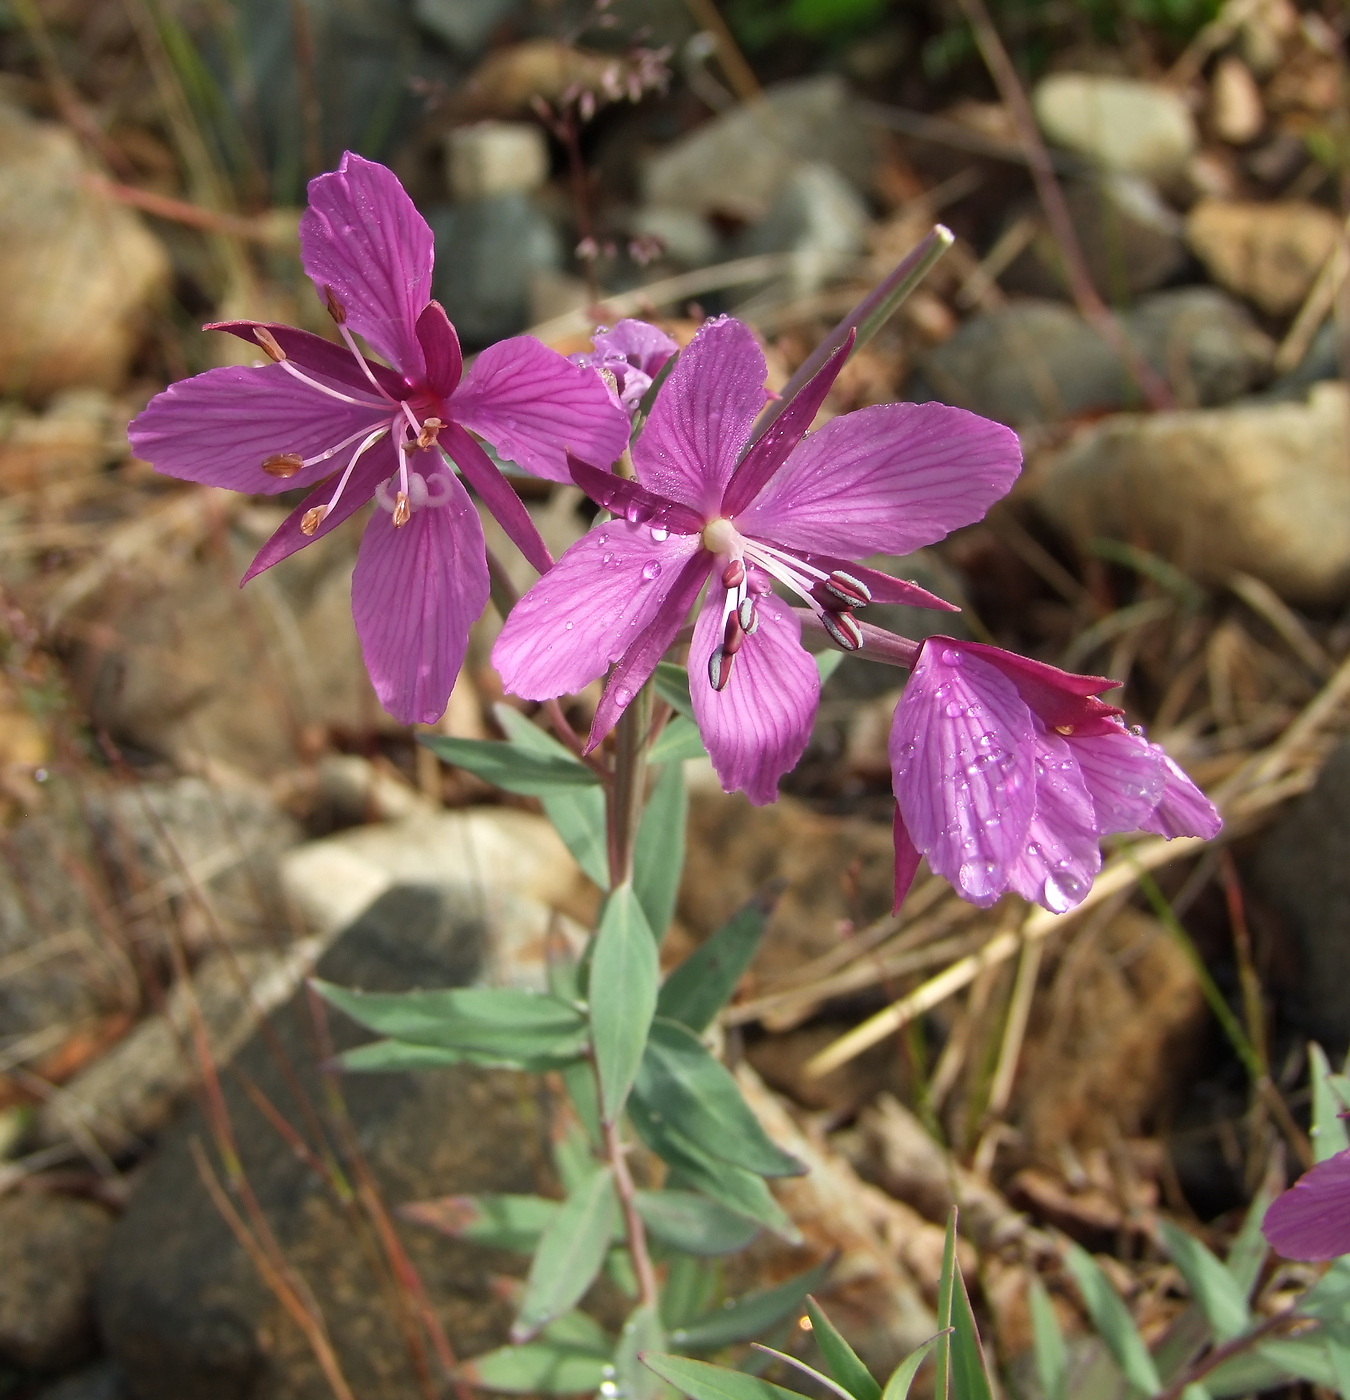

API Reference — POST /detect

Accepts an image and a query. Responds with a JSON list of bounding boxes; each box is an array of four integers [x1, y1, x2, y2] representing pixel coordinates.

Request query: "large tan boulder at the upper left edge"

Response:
[[0, 102, 169, 399]]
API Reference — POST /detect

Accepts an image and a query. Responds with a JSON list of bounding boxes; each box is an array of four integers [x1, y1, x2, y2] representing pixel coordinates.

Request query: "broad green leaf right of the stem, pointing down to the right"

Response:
[[633, 1018, 805, 1176]]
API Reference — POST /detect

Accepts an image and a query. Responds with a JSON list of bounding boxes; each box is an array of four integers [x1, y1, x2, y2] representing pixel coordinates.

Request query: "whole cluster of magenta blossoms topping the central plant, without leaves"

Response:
[[130, 155, 1220, 911]]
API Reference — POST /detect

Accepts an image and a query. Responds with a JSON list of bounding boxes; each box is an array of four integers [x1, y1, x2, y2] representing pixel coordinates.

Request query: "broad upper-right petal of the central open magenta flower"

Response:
[[739, 400, 1022, 559]]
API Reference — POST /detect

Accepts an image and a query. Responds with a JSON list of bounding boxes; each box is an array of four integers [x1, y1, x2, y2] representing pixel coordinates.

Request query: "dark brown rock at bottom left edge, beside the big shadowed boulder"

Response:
[[0, 1193, 112, 1371]]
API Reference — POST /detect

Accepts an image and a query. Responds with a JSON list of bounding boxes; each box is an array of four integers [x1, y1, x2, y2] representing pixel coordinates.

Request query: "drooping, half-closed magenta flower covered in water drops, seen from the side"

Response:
[[891, 637, 1221, 913]]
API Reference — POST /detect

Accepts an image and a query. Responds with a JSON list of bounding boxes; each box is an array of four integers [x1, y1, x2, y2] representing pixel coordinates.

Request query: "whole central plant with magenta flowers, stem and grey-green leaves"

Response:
[[130, 154, 1218, 1400]]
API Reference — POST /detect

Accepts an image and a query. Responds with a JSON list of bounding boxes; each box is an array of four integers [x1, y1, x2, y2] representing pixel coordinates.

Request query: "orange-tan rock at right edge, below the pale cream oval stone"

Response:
[[1186, 199, 1340, 316]]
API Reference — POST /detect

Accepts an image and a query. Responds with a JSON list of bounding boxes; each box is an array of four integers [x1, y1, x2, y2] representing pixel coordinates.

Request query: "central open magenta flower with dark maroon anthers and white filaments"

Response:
[[493, 316, 1021, 802]]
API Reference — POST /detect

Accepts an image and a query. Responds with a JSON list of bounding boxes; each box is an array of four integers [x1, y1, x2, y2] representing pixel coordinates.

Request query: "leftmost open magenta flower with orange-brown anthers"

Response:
[[129, 153, 629, 722]]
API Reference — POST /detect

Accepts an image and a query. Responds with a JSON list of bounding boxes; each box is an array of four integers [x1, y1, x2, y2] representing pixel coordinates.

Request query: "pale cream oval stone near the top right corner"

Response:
[[1031, 73, 1196, 179]]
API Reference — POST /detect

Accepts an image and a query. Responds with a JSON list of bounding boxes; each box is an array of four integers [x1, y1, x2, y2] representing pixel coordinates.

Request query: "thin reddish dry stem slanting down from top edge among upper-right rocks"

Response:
[[958, 0, 1174, 409]]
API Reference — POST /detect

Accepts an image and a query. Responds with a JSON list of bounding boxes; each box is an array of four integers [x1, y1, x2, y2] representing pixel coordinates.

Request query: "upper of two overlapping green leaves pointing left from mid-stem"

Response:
[[312, 979, 585, 1060]]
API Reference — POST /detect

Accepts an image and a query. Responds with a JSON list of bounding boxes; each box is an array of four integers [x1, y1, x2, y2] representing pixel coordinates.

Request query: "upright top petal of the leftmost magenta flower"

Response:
[[300, 151, 436, 381]]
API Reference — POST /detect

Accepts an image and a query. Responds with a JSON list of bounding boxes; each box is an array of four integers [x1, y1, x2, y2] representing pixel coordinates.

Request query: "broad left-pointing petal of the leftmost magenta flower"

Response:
[[127, 364, 391, 496]]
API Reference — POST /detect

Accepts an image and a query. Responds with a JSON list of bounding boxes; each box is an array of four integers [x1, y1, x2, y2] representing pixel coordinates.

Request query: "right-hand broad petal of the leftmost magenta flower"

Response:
[[450, 336, 629, 482]]
